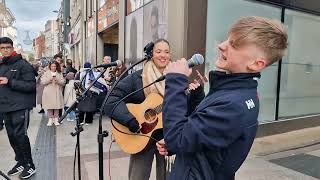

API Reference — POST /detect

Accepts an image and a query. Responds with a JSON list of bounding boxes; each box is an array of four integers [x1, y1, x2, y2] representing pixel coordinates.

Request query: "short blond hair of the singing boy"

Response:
[[228, 16, 288, 65]]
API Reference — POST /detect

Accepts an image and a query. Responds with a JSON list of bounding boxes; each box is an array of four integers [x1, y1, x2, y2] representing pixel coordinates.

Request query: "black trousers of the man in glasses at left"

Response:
[[4, 109, 34, 165]]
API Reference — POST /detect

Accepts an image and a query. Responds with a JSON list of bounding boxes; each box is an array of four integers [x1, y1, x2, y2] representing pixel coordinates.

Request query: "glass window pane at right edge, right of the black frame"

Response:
[[279, 10, 320, 118]]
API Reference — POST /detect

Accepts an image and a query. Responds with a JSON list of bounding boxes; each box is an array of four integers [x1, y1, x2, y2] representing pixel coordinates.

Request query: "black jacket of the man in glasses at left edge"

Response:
[[0, 54, 36, 112]]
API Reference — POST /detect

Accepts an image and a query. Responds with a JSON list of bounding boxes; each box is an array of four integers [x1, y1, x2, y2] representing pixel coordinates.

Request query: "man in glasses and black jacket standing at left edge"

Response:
[[0, 37, 36, 179]]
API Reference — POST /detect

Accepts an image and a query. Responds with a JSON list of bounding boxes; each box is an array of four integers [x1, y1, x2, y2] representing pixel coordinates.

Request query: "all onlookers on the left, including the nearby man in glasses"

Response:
[[0, 37, 119, 179]]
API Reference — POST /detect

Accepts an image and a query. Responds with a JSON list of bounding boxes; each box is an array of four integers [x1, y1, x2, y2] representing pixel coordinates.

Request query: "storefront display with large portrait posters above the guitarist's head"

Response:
[[125, 0, 168, 71]]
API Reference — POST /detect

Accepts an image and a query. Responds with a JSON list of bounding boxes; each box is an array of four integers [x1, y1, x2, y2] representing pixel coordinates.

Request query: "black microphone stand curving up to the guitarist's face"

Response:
[[98, 54, 152, 180]]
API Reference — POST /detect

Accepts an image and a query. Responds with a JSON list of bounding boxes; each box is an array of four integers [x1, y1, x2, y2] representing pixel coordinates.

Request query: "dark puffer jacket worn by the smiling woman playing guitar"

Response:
[[104, 70, 204, 126]]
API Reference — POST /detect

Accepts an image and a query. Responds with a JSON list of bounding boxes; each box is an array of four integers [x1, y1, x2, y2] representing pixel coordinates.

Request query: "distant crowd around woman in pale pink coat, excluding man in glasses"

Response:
[[35, 55, 115, 126]]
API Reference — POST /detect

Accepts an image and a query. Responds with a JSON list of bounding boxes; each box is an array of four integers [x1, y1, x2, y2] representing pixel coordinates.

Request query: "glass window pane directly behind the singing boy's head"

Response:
[[205, 0, 281, 121]]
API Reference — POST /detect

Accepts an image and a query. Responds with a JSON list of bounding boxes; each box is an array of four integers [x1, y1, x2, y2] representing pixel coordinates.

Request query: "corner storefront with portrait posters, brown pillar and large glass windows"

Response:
[[124, 0, 320, 129]]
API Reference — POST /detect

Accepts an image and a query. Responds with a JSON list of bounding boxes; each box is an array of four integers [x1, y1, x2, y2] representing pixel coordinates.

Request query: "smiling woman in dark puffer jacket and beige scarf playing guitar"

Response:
[[104, 39, 204, 180]]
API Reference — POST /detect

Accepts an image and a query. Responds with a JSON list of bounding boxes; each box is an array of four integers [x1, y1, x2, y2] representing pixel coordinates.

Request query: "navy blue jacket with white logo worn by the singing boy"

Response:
[[163, 71, 260, 180]]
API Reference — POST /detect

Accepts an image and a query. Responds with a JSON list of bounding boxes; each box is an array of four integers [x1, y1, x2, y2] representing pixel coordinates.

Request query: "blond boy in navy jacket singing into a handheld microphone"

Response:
[[157, 17, 288, 180]]
